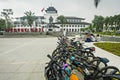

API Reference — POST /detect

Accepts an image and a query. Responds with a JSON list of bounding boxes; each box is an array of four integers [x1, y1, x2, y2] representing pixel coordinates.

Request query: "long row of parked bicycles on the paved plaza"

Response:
[[44, 36, 120, 80]]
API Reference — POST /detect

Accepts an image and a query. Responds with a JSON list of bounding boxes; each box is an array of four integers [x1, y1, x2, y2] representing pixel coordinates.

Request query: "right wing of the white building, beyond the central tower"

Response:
[[55, 16, 90, 32]]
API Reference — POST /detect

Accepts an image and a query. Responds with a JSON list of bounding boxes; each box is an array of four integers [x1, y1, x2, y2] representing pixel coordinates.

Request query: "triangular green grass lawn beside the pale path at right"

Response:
[[94, 42, 120, 56]]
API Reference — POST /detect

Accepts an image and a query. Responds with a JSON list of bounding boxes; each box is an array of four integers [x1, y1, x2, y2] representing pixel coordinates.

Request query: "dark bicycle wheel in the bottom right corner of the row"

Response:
[[94, 66, 120, 80]]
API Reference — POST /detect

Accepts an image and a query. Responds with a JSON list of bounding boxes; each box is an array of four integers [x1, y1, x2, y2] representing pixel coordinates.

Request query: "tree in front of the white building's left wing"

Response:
[[23, 11, 36, 27]]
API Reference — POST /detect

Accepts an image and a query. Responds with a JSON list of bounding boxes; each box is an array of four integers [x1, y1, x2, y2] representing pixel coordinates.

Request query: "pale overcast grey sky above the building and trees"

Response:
[[0, 0, 120, 22]]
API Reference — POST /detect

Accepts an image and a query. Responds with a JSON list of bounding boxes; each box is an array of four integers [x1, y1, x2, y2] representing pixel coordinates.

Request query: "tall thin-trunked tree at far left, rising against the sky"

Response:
[[1, 9, 13, 28]]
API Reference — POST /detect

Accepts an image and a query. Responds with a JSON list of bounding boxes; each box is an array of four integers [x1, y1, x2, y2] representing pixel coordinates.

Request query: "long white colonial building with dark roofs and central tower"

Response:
[[7, 6, 90, 32]]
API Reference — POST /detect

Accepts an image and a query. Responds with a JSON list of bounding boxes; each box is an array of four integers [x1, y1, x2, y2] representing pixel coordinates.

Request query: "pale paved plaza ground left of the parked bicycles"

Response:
[[0, 38, 57, 80]]
